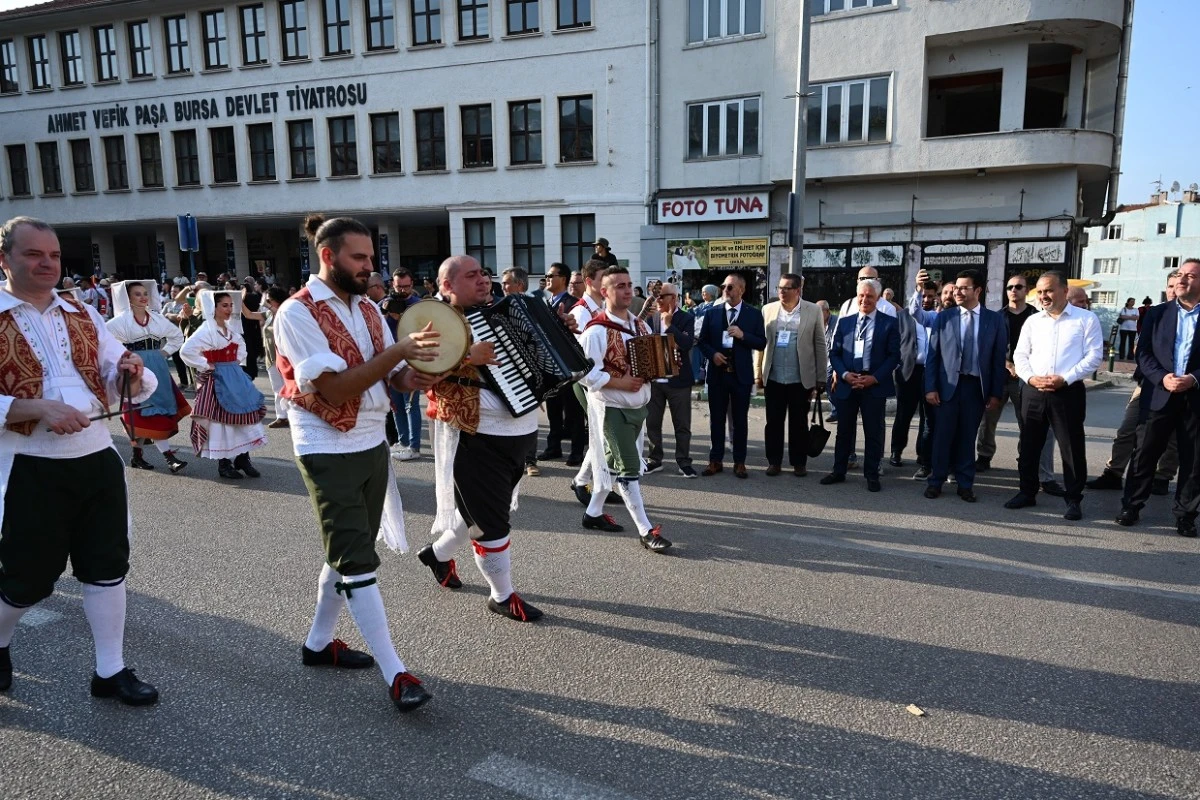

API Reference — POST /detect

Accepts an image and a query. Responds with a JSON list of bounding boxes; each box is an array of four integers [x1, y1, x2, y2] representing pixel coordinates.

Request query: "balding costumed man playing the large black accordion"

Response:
[[416, 255, 541, 622]]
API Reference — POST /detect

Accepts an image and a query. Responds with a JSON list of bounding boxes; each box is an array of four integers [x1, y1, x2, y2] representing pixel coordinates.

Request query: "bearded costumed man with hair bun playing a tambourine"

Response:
[[272, 215, 438, 711]]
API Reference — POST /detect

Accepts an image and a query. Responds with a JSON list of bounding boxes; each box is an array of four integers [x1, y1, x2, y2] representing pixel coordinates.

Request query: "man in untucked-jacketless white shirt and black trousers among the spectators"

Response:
[[1004, 271, 1104, 521]]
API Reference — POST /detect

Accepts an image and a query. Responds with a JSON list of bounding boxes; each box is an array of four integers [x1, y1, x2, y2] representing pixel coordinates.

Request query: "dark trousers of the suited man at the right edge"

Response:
[[1122, 392, 1200, 521]]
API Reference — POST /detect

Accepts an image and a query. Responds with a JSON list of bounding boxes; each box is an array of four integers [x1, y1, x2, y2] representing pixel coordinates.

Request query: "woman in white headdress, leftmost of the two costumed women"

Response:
[[107, 281, 192, 474]]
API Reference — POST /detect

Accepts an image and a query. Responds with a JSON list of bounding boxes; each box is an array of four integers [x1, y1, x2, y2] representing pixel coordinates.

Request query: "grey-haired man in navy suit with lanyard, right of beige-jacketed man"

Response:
[[821, 278, 900, 492]]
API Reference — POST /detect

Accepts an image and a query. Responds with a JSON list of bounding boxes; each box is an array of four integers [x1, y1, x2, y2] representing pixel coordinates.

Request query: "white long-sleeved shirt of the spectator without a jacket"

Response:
[[1013, 303, 1104, 385]]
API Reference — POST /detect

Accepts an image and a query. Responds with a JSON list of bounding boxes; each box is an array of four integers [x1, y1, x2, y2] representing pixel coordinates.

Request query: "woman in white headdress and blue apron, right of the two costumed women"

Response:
[[179, 289, 266, 479]]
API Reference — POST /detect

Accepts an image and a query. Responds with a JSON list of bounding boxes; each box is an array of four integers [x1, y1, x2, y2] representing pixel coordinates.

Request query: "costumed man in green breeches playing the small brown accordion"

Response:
[[580, 266, 671, 553]]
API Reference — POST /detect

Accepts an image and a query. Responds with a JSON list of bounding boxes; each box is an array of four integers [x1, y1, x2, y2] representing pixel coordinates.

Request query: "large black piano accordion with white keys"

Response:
[[467, 295, 595, 416]]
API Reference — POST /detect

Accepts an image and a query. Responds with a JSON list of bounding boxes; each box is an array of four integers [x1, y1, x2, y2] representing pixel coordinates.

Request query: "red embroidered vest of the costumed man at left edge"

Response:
[[0, 297, 108, 437]]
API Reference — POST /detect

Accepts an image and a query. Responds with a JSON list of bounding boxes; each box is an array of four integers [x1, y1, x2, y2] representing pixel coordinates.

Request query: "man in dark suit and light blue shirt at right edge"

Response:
[[1117, 258, 1200, 537]]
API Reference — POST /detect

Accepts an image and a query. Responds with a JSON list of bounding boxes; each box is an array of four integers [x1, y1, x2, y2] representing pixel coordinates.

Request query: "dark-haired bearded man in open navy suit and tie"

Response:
[[922, 270, 1008, 503]]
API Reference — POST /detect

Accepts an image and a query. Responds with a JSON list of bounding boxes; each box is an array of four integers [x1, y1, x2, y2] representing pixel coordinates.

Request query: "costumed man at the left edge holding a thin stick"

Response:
[[0, 217, 158, 705]]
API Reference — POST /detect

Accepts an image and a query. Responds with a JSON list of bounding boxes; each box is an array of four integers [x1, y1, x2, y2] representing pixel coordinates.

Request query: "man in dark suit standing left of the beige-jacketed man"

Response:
[[696, 272, 767, 477]]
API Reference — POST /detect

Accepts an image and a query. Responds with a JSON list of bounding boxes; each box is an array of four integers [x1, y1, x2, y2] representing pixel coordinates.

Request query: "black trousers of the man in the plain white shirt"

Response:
[[1022, 380, 1087, 503]]
